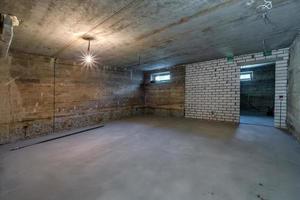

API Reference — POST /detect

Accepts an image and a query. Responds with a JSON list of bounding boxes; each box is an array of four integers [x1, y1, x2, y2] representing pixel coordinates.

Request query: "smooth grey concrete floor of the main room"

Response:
[[0, 117, 300, 200]]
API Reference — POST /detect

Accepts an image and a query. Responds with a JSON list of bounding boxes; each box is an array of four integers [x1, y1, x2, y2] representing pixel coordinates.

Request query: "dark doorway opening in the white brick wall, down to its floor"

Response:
[[240, 64, 275, 126]]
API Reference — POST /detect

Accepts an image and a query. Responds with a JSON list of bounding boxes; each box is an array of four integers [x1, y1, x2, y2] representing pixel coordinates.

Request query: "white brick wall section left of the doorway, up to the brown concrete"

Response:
[[185, 59, 240, 122]]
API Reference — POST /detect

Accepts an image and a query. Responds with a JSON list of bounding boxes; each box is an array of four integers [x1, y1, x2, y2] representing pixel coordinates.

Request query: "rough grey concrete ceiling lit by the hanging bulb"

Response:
[[0, 0, 300, 69]]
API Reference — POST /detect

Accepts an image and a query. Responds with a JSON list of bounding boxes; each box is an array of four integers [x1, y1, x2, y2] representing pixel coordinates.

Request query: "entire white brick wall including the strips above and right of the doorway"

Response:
[[185, 48, 289, 128]]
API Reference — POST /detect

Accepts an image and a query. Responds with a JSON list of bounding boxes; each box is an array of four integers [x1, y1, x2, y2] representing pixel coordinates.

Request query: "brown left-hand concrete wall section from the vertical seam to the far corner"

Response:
[[55, 61, 143, 130]]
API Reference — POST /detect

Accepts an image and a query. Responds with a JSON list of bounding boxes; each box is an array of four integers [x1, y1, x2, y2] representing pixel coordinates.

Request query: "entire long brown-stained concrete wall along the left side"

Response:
[[0, 54, 143, 143]]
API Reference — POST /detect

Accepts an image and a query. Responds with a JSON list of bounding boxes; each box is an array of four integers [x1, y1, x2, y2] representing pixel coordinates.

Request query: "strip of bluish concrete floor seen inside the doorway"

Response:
[[240, 115, 274, 127]]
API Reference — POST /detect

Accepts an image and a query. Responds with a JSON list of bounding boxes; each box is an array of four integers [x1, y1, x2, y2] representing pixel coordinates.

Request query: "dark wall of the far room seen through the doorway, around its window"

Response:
[[240, 64, 275, 116]]
